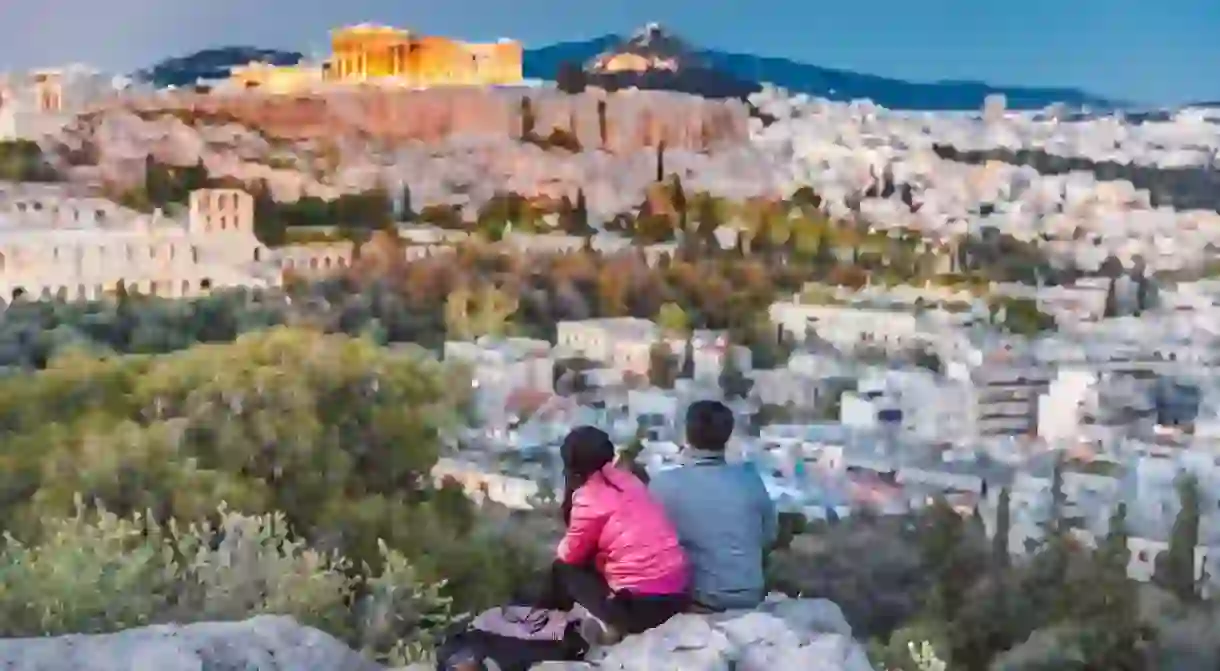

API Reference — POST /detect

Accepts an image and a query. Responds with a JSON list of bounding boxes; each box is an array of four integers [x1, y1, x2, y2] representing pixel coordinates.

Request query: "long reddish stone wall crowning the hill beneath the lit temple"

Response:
[[107, 87, 749, 153]]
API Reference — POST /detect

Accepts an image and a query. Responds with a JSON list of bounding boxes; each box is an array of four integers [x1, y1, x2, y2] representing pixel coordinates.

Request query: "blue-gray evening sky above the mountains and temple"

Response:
[[0, 0, 1220, 104]]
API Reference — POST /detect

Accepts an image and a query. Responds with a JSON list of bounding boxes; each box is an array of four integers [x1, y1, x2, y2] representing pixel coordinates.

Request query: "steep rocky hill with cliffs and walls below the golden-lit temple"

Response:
[[56, 89, 775, 220]]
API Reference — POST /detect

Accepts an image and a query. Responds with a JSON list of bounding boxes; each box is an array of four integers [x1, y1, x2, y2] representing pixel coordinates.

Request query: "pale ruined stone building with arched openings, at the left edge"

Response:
[[0, 185, 351, 303]]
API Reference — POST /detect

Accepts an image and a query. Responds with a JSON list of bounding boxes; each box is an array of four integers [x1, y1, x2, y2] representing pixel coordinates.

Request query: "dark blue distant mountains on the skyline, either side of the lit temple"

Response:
[[137, 24, 1124, 111]]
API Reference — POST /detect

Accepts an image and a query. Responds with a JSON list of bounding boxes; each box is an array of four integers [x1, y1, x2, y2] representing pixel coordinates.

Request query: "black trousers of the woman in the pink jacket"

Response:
[[542, 561, 688, 634]]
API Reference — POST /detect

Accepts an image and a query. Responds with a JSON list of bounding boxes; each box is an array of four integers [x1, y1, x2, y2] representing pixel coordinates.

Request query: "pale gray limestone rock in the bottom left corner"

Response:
[[0, 616, 381, 671]]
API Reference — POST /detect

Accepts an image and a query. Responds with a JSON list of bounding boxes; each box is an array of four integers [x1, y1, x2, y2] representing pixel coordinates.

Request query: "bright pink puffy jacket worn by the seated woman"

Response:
[[556, 465, 688, 595]]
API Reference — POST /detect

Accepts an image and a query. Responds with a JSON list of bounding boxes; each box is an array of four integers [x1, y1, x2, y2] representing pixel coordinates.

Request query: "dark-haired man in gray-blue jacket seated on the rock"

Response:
[[649, 400, 778, 611]]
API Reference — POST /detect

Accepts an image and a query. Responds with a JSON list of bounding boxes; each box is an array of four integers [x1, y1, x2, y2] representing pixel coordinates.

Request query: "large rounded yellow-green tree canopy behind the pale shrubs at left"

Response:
[[0, 328, 539, 624]]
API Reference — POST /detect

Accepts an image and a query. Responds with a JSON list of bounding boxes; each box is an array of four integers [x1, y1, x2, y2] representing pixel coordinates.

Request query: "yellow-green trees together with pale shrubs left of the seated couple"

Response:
[[0, 328, 549, 659]]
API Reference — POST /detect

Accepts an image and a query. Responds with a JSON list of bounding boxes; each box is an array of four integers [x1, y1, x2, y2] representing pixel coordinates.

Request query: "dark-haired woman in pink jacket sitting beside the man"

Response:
[[550, 426, 689, 644]]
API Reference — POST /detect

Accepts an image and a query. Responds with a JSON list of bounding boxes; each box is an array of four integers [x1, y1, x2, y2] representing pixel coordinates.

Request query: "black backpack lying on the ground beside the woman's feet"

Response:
[[437, 606, 588, 671]]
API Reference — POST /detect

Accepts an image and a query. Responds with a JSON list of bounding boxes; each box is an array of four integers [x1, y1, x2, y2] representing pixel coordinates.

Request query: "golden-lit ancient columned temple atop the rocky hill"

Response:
[[233, 24, 522, 92]]
